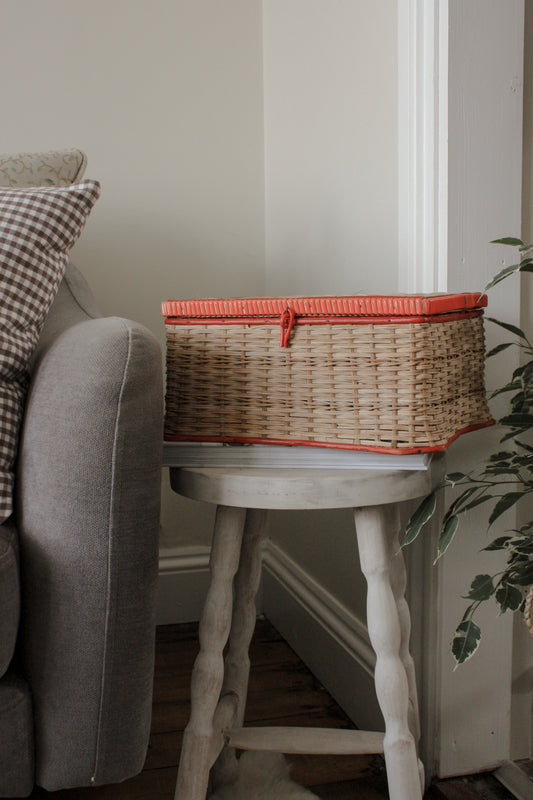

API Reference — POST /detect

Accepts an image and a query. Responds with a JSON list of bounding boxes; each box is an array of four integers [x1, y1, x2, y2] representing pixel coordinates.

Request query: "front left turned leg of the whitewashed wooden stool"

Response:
[[174, 506, 246, 800]]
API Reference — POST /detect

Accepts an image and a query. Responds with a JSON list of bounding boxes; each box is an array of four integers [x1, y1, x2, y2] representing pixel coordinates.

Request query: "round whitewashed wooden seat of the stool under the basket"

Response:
[[170, 453, 445, 510]]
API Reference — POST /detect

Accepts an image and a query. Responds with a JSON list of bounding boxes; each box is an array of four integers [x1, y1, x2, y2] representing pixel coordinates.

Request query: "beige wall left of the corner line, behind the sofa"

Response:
[[0, 0, 264, 547]]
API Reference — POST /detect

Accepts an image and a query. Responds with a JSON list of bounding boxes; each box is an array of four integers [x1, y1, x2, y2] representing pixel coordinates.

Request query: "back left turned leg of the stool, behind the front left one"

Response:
[[213, 509, 267, 788]]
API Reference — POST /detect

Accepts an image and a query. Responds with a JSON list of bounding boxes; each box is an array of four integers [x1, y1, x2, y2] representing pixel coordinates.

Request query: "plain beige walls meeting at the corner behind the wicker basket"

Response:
[[0, 0, 397, 576]]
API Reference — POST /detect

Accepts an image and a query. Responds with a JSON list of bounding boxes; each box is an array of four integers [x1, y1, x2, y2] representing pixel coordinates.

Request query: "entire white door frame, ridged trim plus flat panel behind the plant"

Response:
[[398, 0, 524, 776]]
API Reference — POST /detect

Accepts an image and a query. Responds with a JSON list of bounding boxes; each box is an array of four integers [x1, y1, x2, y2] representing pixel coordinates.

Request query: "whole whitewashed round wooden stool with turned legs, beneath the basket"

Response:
[[170, 456, 444, 800]]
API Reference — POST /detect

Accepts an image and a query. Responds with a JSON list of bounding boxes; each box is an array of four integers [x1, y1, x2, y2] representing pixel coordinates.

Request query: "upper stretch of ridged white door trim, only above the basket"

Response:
[[398, 0, 448, 292]]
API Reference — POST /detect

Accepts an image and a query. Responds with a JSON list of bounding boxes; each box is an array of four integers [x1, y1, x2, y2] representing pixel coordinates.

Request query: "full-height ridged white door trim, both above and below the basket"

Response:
[[398, 0, 449, 775]]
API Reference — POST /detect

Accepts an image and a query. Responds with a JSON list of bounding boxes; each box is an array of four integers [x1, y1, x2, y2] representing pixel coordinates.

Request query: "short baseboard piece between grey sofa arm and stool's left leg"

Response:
[[156, 547, 210, 625]]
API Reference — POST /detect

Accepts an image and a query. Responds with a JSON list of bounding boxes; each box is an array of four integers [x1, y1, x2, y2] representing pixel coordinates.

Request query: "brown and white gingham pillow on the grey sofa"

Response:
[[0, 180, 100, 523]]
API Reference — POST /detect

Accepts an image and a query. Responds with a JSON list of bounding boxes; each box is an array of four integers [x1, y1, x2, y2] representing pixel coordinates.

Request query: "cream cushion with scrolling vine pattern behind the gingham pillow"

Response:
[[0, 148, 87, 188]]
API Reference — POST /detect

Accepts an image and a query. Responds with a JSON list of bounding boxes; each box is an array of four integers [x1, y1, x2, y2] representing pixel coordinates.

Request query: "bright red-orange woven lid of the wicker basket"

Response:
[[161, 292, 487, 319]]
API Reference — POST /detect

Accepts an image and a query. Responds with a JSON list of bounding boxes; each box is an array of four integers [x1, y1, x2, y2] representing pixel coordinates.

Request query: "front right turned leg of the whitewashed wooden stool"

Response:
[[354, 505, 422, 800]]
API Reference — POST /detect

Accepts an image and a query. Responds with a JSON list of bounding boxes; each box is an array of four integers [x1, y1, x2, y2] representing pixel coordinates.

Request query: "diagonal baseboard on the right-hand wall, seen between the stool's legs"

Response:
[[262, 541, 383, 730]]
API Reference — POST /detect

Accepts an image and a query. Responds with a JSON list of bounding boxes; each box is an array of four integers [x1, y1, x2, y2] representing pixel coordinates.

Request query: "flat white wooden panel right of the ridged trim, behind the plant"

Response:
[[438, 0, 524, 775]]
